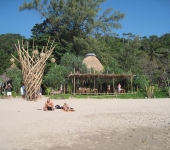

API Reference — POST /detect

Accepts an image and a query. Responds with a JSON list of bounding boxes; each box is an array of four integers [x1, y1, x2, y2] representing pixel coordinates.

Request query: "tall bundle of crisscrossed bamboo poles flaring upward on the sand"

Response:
[[12, 38, 56, 101]]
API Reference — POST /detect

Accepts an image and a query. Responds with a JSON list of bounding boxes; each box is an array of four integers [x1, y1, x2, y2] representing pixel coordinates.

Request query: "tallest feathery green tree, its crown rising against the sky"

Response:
[[19, 0, 125, 54]]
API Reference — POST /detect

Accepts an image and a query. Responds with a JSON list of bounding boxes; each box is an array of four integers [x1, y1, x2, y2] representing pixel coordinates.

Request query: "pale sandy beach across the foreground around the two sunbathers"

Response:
[[0, 97, 170, 150]]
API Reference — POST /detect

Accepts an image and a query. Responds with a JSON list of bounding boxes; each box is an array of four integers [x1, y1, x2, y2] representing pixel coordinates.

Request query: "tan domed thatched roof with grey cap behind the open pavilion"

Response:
[[83, 53, 103, 72]]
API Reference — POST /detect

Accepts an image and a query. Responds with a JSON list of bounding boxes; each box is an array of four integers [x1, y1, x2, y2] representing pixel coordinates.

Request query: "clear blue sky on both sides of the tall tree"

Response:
[[0, 0, 170, 38]]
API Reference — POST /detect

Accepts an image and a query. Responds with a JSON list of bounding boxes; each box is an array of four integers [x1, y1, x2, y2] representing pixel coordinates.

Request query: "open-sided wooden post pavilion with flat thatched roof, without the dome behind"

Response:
[[68, 72, 134, 94]]
